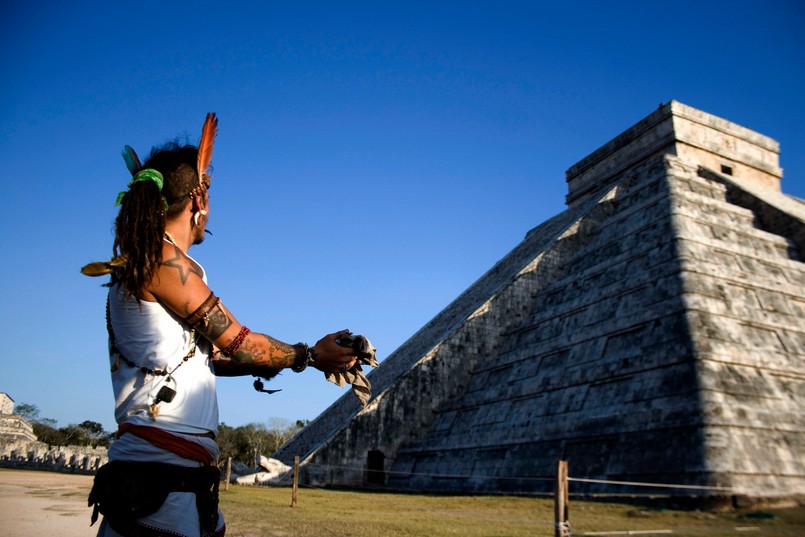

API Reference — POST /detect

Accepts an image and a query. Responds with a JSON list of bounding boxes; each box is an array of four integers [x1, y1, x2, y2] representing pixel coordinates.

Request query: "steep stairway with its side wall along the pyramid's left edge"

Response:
[[274, 193, 594, 468]]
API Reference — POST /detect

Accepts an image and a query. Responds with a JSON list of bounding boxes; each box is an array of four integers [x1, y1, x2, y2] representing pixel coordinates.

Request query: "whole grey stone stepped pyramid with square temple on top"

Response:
[[274, 101, 805, 498]]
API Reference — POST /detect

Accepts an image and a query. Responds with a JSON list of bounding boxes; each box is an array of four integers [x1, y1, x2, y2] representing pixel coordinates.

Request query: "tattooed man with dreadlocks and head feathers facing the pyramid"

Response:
[[82, 114, 359, 537]]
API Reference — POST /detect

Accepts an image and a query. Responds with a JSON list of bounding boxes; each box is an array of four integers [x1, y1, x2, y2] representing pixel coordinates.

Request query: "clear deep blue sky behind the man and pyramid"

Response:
[[0, 0, 805, 430]]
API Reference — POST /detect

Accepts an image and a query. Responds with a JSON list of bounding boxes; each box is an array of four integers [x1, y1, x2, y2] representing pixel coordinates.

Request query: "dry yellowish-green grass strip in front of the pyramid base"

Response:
[[220, 486, 805, 537]]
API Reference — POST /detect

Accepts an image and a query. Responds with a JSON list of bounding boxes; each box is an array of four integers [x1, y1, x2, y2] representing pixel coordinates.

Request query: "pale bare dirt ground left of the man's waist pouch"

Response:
[[0, 469, 98, 537]]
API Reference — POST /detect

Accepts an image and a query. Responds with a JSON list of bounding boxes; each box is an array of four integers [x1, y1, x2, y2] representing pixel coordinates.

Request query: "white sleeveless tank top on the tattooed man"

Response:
[[109, 253, 218, 434]]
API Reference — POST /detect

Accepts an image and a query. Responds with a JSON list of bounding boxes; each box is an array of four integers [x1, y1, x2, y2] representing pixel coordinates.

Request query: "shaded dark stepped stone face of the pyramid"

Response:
[[389, 153, 709, 492]]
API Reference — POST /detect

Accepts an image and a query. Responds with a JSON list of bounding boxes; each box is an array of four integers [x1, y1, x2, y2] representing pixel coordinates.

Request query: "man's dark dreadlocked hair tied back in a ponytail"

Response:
[[113, 142, 199, 301]]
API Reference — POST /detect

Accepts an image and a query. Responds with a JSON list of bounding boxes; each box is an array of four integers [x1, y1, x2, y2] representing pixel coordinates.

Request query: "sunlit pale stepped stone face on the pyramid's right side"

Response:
[[674, 160, 805, 494]]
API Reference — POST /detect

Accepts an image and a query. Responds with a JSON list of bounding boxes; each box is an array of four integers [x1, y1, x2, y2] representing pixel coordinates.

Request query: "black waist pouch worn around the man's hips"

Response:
[[87, 461, 221, 531]]
